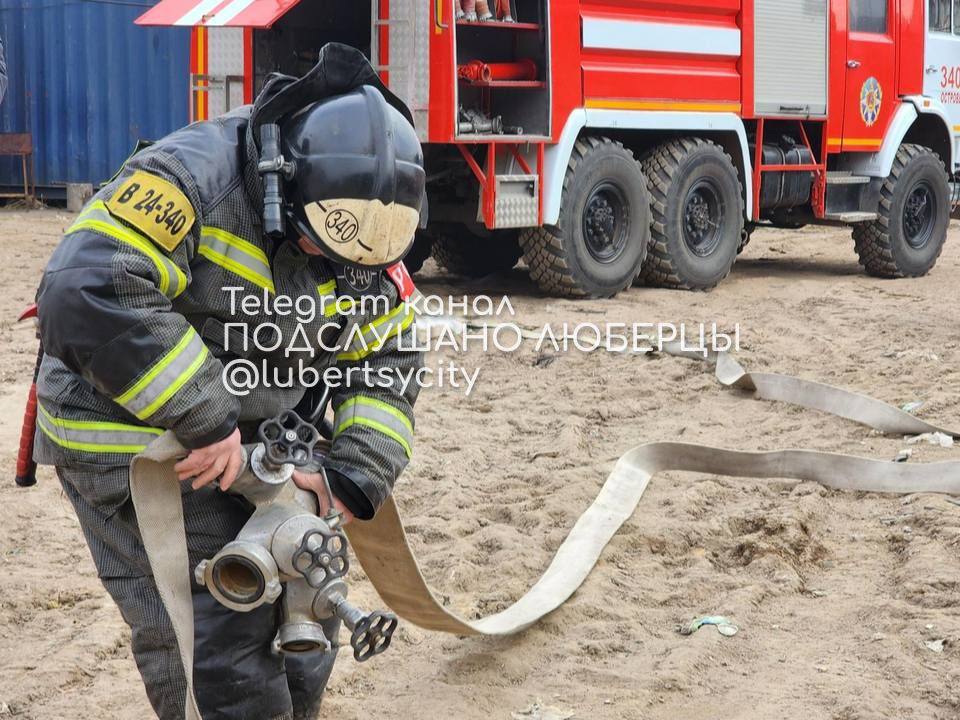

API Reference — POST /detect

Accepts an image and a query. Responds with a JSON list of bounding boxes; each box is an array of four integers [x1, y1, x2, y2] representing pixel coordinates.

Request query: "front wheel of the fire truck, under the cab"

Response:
[[853, 145, 950, 278]]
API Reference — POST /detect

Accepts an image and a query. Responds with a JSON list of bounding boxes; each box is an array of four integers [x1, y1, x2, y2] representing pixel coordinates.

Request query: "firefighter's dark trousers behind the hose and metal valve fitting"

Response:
[[57, 465, 339, 720]]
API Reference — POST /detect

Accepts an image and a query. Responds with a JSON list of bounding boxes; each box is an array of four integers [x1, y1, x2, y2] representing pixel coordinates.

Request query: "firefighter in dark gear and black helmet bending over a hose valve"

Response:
[[36, 46, 424, 720]]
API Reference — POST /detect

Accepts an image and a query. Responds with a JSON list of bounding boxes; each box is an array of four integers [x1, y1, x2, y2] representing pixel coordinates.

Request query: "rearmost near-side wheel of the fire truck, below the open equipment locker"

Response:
[[520, 137, 650, 297]]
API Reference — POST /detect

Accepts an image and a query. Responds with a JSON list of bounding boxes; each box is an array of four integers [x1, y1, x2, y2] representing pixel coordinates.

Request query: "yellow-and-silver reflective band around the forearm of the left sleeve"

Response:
[[114, 327, 208, 420]]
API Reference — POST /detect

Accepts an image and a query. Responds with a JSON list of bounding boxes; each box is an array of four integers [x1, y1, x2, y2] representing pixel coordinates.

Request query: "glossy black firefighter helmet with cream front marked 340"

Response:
[[280, 85, 425, 269]]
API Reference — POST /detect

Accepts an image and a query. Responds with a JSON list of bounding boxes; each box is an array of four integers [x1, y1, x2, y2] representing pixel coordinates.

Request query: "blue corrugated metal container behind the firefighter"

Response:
[[0, 0, 190, 197]]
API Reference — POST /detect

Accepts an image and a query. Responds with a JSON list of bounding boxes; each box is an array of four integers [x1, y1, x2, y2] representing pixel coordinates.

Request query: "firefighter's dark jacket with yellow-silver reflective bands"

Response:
[[35, 49, 422, 517]]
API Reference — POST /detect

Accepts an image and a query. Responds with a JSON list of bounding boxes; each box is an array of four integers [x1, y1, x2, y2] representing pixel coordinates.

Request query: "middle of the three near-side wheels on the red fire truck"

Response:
[[640, 138, 746, 290]]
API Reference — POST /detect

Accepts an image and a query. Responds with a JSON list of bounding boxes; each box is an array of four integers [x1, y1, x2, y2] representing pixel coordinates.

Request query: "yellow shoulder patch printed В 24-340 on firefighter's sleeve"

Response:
[[106, 170, 197, 252]]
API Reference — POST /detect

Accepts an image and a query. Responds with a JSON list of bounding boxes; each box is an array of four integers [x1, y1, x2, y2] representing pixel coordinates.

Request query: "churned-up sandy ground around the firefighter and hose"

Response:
[[0, 211, 960, 720]]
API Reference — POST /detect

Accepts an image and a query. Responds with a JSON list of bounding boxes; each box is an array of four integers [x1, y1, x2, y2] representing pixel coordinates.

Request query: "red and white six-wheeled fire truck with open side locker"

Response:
[[138, 0, 960, 297]]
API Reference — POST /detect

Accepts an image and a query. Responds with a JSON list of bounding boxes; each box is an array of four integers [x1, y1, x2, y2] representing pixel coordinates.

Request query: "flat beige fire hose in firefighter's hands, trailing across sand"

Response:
[[130, 346, 960, 720]]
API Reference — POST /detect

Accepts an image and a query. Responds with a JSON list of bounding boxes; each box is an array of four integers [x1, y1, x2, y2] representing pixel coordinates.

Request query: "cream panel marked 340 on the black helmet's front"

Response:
[[304, 198, 420, 268]]
